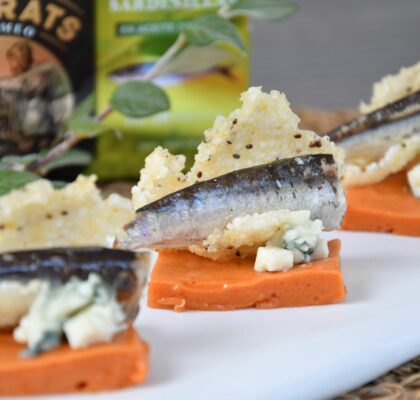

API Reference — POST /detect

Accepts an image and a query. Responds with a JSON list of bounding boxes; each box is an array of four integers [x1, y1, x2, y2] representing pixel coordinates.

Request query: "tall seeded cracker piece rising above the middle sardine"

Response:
[[132, 87, 344, 209]]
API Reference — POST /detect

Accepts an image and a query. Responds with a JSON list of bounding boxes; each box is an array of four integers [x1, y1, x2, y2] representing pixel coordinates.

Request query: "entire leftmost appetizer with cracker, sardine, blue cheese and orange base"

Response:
[[0, 176, 154, 395]]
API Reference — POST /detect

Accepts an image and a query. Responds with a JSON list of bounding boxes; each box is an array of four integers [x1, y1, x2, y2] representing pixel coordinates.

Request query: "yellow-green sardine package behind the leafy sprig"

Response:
[[90, 0, 249, 179]]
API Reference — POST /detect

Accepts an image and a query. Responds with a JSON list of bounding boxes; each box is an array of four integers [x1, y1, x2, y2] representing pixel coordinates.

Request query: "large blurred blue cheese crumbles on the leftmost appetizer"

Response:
[[13, 273, 125, 356]]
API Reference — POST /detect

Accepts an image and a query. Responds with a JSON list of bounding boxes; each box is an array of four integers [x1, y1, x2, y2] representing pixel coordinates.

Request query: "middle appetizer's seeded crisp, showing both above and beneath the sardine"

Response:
[[132, 87, 344, 260]]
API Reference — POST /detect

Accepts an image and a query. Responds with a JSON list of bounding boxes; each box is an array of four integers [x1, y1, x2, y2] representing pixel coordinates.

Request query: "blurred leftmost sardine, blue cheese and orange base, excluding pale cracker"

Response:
[[0, 248, 151, 395]]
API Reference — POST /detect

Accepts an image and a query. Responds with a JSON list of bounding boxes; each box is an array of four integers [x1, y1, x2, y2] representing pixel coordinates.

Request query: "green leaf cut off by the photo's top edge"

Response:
[[221, 0, 300, 21]]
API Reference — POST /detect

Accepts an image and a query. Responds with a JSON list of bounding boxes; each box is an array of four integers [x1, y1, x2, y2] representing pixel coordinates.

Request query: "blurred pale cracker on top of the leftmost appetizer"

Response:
[[0, 176, 134, 252]]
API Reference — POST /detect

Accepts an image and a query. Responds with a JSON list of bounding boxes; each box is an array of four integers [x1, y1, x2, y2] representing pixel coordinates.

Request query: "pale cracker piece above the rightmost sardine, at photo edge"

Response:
[[360, 62, 420, 114]]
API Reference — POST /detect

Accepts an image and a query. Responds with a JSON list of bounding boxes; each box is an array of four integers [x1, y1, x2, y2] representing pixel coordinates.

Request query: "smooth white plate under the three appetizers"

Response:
[[9, 232, 420, 400]]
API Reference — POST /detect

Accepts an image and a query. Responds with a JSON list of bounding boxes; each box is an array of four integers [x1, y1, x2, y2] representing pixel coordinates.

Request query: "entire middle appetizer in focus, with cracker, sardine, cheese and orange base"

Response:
[[118, 88, 346, 311]]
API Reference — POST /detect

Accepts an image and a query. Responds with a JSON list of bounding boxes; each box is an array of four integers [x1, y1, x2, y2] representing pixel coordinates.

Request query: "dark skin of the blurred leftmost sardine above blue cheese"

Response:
[[0, 247, 147, 321]]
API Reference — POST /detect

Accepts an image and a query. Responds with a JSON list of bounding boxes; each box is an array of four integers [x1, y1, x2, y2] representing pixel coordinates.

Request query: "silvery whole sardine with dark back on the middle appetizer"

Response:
[[119, 154, 346, 250]]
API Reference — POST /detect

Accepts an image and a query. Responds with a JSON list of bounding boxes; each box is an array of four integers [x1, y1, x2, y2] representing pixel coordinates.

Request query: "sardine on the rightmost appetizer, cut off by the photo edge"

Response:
[[326, 90, 420, 162]]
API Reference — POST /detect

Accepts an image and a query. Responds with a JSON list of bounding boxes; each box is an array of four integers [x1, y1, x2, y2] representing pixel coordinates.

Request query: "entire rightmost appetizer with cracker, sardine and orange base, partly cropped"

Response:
[[327, 63, 420, 236]]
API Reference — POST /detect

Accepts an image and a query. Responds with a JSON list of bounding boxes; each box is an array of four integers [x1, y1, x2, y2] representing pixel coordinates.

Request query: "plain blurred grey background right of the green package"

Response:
[[251, 0, 420, 108]]
